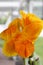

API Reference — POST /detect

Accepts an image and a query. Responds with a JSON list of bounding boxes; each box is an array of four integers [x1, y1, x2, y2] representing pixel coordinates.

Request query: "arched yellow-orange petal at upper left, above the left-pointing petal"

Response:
[[9, 18, 24, 32]]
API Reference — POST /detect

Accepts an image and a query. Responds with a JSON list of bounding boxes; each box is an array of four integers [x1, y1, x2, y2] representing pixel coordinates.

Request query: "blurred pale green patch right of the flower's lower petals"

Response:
[[35, 37, 43, 65]]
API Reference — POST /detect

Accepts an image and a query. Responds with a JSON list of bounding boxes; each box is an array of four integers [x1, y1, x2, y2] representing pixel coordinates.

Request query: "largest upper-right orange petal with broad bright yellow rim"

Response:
[[20, 11, 42, 41]]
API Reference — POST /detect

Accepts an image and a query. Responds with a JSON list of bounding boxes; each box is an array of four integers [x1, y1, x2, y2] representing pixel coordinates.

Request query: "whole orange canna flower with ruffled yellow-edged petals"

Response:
[[0, 11, 42, 58]]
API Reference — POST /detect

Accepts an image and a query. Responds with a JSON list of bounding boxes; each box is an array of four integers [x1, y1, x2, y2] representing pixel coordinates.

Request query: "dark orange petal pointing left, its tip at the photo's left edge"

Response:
[[0, 26, 16, 40]]
